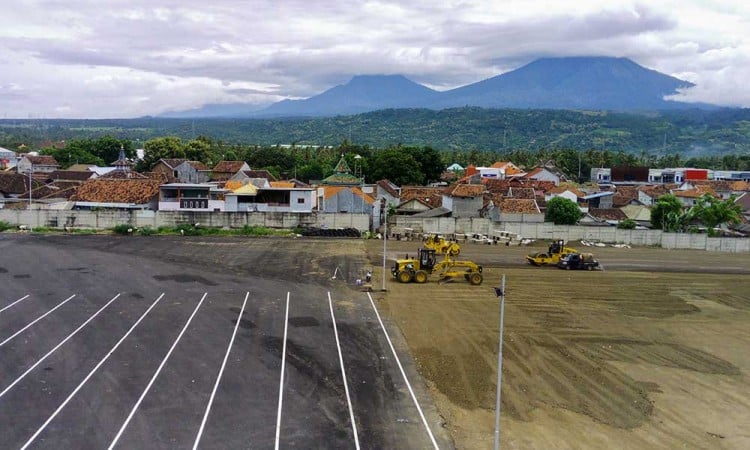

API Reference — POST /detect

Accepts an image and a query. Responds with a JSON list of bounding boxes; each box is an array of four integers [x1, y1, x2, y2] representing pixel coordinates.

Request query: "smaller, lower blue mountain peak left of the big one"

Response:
[[257, 75, 438, 117]]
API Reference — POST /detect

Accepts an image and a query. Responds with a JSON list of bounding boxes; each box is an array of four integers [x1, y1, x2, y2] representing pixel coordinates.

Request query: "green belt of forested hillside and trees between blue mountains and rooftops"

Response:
[[0, 108, 750, 185]]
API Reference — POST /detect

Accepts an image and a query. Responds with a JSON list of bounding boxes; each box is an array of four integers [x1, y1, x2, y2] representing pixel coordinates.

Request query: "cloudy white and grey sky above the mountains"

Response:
[[0, 0, 750, 118]]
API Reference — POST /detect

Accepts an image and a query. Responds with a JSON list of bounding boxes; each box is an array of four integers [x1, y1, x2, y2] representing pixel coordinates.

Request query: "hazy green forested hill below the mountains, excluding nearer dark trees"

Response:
[[0, 108, 750, 157]]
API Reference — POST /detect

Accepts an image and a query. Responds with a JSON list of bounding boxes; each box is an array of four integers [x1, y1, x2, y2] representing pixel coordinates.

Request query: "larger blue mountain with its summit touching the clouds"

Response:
[[430, 57, 695, 111]]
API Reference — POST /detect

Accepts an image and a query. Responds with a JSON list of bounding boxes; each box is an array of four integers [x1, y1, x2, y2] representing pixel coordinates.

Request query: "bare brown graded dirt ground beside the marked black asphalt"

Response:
[[366, 237, 750, 449]]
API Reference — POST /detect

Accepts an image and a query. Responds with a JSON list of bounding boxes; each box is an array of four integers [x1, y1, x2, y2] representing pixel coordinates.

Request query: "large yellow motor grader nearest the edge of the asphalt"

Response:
[[391, 248, 483, 286]]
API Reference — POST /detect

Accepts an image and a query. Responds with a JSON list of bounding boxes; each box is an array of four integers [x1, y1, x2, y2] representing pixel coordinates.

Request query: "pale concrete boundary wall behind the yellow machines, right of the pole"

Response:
[[388, 216, 750, 252]]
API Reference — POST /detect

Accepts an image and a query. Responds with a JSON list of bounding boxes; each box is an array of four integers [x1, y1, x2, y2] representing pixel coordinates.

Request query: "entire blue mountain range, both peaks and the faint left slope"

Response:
[[163, 56, 711, 118]]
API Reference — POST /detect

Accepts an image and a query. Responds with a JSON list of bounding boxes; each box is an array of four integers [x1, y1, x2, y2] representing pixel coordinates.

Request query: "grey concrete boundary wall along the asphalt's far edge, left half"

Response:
[[0, 209, 370, 231]]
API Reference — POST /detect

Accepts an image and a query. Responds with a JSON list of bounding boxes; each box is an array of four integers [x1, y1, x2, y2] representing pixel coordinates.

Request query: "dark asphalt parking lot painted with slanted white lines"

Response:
[[0, 235, 452, 449]]
